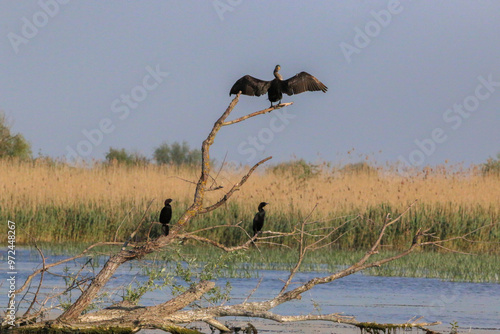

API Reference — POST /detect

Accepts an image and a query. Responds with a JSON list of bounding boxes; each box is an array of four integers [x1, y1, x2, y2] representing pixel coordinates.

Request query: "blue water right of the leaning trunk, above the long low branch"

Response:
[[217, 271, 500, 333]]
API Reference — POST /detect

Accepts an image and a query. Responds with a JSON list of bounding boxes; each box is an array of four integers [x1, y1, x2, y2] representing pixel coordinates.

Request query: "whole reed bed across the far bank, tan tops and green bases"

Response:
[[0, 159, 500, 253]]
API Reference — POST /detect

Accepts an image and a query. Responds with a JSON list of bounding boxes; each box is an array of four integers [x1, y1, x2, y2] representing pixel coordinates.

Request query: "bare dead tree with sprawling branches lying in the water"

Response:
[[3, 94, 484, 333]]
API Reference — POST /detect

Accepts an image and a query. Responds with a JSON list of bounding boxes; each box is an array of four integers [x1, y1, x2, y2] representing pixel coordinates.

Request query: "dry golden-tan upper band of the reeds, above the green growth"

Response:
[[0, 159, 500, 248]]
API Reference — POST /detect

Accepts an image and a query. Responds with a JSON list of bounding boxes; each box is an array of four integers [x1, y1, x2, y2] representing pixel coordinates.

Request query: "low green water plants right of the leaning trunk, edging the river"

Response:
[[182, 247, 500, 283]]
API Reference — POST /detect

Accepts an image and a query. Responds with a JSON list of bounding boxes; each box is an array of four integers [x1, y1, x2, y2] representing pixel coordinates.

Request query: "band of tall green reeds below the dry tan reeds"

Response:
[[0, 202, 500, 254]]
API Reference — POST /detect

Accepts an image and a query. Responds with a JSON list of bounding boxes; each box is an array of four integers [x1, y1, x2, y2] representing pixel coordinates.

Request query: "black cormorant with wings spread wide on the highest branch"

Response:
[[229, 65, 328, 107]]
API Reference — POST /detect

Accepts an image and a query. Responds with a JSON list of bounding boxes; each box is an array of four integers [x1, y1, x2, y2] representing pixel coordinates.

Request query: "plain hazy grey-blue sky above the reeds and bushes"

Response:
[[0, 0, 500, 167]]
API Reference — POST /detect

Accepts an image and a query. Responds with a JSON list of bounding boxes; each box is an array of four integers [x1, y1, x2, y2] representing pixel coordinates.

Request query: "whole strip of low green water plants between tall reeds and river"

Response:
[[26, 244, 500, 283]]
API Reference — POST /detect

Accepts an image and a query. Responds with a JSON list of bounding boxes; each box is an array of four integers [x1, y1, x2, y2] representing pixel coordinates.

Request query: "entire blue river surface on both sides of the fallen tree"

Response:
[[0, 248, 500, 334]]
